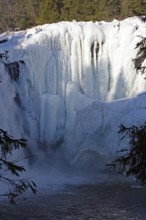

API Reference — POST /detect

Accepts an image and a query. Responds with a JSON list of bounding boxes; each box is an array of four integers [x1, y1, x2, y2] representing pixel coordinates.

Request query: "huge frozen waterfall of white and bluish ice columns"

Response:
[[0, 17, 146, 168]]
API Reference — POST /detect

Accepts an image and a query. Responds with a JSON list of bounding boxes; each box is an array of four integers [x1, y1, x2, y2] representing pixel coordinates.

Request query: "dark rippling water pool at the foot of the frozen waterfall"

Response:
[[0, 184, 146, 220]]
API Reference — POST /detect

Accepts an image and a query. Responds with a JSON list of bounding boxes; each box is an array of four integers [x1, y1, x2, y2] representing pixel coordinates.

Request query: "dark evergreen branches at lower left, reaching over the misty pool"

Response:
[[0, 129, 36, 203]]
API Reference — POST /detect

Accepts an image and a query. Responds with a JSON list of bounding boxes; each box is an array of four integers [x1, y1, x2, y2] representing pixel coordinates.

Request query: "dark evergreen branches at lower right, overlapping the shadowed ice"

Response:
[[107, 123, 146, 185]]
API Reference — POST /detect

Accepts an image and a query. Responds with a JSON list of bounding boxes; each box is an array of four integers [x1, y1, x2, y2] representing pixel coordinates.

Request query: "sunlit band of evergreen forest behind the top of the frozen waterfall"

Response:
[[0, 0, 146, 32]]
